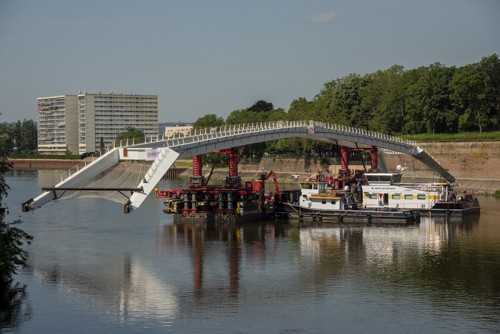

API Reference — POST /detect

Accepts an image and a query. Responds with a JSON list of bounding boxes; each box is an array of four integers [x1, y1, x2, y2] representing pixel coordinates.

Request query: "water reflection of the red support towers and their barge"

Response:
[[157, 222, 288, 302]]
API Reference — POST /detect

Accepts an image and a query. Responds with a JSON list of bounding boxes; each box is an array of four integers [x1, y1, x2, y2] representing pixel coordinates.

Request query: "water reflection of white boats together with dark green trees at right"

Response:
[[300, 216, 500, 322]]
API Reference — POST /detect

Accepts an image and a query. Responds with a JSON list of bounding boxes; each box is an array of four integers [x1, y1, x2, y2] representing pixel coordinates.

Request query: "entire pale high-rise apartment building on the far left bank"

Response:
[[37, 93, 158, 154]]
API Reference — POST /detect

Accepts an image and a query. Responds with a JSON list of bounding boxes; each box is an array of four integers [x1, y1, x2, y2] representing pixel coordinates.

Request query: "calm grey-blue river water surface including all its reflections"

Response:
[[0, 171, 500, 333]]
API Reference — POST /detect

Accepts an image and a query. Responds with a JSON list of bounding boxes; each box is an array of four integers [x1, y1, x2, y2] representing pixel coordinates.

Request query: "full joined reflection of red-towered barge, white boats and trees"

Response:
[[157, 216, 500, 320]]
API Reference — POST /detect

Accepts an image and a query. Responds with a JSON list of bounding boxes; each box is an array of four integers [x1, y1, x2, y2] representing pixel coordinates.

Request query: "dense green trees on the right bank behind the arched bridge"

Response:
[[194, 54, 500, 158]]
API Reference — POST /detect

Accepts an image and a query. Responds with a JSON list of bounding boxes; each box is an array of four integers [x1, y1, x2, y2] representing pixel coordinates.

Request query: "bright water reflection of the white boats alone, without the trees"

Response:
[[300, 216, 479, 269]]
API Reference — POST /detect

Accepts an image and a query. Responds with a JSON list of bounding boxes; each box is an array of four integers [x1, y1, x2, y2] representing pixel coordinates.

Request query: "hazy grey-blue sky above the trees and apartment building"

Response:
[[0, 0, 500, 122]]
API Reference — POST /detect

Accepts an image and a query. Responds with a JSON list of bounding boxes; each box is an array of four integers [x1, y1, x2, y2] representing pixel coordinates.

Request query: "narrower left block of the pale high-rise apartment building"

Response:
[[36, 95, 78, 154]]
